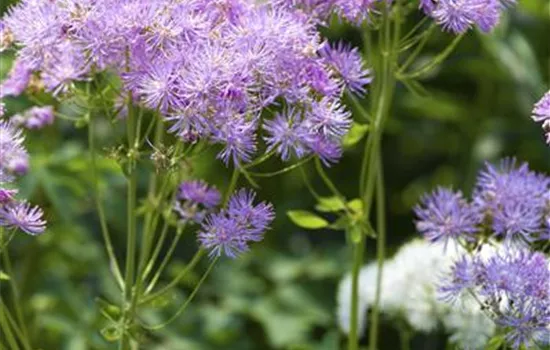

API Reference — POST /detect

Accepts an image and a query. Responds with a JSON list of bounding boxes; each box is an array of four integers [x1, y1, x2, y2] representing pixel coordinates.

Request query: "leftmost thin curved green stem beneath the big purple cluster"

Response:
[[88, 115, 124, 288]]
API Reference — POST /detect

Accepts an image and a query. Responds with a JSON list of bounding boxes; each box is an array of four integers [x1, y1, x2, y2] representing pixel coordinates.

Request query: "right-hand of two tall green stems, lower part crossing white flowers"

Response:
[[369, 152, 386, 350]]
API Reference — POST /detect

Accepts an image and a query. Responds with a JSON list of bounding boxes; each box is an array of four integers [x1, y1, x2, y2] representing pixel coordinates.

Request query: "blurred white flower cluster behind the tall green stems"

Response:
[[338, 239, 496, 349]]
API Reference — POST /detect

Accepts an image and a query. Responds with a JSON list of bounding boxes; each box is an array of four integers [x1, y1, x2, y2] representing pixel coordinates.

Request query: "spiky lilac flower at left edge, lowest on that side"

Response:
[[0, 202, 46, 236]]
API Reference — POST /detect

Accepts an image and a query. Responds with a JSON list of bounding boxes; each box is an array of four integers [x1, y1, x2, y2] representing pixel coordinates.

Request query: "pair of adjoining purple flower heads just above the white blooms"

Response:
[[415, 159, 550, 245]]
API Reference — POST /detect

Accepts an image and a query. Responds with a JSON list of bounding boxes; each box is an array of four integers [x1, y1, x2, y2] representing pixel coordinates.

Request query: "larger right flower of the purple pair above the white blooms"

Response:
[[474, 159, 550, 242]]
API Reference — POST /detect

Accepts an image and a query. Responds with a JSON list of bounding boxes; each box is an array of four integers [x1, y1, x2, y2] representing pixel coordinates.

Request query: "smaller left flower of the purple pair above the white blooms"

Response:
[[414, 188, 481, 246]]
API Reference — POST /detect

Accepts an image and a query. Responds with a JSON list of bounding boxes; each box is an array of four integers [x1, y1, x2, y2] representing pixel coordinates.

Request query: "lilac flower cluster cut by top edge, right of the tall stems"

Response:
[[420, 0, 515, 34]]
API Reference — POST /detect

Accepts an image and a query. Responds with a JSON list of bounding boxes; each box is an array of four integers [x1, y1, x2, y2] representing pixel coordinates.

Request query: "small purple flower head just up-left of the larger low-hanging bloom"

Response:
[[174, 180, 221, 223]]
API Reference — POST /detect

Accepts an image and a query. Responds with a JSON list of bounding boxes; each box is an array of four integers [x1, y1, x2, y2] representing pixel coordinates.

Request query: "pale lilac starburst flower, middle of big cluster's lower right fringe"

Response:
[[263, 109, 307, 161]]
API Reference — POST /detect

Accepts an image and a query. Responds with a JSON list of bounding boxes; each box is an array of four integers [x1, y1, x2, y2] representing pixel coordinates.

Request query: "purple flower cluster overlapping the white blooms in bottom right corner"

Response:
[[440, 249, 550, 349]]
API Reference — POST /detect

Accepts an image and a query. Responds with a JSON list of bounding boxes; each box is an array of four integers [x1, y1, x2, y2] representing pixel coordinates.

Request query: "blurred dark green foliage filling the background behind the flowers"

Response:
[[0, 0, 550, 350]]
